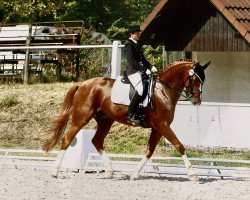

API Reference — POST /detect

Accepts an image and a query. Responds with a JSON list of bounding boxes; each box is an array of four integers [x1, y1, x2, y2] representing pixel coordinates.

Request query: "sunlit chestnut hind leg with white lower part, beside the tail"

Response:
[[52, 109, 93, 178]]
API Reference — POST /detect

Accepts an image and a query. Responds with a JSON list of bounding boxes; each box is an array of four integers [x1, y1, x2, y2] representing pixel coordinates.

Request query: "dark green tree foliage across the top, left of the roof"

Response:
[[0, 0, 158, 39]]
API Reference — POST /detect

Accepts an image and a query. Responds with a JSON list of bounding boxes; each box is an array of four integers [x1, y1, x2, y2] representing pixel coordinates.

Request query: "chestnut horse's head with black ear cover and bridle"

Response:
[[184, 61, 211, 105]]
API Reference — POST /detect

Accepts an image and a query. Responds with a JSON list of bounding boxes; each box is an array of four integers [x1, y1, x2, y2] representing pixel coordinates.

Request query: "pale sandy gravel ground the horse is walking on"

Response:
[[0, 168, 250, 200]]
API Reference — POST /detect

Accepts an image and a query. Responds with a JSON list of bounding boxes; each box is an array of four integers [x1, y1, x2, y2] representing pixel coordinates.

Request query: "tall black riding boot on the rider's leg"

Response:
[[127, 91, 141, 124]]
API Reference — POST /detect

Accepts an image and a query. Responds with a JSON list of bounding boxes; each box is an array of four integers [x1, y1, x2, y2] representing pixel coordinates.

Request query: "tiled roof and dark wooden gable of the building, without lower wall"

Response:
[[141, 0, 250, 51]]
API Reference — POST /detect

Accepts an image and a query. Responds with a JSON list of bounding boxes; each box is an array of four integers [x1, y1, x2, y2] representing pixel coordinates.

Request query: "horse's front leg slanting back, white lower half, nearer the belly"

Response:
[[131, 129, 162, 180]]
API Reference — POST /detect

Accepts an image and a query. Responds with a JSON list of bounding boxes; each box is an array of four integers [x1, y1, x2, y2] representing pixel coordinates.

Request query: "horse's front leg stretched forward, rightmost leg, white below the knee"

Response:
[[161, 126, 198, 181]]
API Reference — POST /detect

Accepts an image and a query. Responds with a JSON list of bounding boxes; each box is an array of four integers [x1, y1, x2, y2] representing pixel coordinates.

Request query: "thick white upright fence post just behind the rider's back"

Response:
[[111, 40, 121, 79]]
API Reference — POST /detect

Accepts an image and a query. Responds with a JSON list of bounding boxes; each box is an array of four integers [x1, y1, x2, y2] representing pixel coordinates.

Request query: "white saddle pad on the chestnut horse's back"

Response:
[[111, 76, 149, 107]]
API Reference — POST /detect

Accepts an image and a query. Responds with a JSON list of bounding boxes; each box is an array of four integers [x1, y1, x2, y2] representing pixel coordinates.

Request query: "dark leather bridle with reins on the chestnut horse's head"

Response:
[[155, 65, 205, 100]]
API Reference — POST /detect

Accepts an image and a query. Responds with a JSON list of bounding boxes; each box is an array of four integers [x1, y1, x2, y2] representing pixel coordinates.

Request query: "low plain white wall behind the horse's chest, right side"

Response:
[[171, 102, 250, 149]]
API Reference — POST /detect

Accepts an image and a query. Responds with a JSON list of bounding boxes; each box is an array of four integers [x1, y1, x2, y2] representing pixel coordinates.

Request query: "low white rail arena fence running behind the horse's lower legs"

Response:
[[0, 149, 250, 179]]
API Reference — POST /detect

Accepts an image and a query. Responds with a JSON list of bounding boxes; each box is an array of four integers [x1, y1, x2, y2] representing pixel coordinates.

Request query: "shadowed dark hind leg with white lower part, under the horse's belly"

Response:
[[92, 115, 114, 178]]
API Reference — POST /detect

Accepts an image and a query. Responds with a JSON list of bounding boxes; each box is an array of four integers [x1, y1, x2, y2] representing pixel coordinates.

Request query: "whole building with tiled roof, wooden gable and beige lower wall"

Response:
[[141, 0, 250, 103]]
